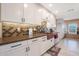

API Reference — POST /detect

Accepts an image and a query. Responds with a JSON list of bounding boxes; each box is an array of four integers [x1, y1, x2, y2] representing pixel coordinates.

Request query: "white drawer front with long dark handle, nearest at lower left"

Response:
[[0, 41, 27, 52]]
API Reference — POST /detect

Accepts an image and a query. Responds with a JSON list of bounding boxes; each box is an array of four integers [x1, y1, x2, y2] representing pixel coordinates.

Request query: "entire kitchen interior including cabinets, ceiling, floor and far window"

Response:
[[0, 3, 79, 56]]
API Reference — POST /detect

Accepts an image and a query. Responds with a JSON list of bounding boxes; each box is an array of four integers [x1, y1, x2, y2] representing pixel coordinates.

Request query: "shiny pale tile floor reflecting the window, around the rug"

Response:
[[44, 38, 79, 56]]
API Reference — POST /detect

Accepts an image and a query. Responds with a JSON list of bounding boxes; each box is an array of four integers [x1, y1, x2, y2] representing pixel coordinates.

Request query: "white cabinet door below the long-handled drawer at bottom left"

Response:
[[5, 47, 27, 56]]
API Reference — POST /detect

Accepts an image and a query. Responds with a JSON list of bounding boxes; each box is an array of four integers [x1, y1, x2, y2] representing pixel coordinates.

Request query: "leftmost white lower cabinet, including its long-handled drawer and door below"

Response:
[[0, 41, 28, 56]]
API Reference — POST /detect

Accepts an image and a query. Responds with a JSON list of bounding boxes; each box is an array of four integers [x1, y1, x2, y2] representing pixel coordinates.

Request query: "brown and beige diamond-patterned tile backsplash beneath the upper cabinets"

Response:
[[2, 22, 42, 38]]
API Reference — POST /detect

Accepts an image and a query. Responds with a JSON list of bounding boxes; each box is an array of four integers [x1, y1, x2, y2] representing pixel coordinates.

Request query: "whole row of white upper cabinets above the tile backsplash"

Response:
[[1, 3, 56, 27]]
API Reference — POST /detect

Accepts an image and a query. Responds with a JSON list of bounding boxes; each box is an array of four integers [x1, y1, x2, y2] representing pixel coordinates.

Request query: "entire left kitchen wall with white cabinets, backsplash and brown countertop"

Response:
[[0, 3, 64, 56]]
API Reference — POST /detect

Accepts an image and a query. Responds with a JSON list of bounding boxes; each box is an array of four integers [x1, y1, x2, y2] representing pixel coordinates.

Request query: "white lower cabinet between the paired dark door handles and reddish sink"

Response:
[[28, 36, 48, 56]]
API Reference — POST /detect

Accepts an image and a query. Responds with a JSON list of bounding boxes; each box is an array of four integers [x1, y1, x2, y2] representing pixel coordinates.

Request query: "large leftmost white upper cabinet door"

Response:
[[2, 3, 23, 22]]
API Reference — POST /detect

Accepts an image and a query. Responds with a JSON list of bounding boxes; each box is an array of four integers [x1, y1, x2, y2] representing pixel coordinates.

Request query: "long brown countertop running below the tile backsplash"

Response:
[[0, 33, 46, 45]]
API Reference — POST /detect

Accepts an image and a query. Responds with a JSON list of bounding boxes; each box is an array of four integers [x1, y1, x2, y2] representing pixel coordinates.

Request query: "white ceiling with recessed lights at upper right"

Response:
[[41, 3, 79, 20]]
